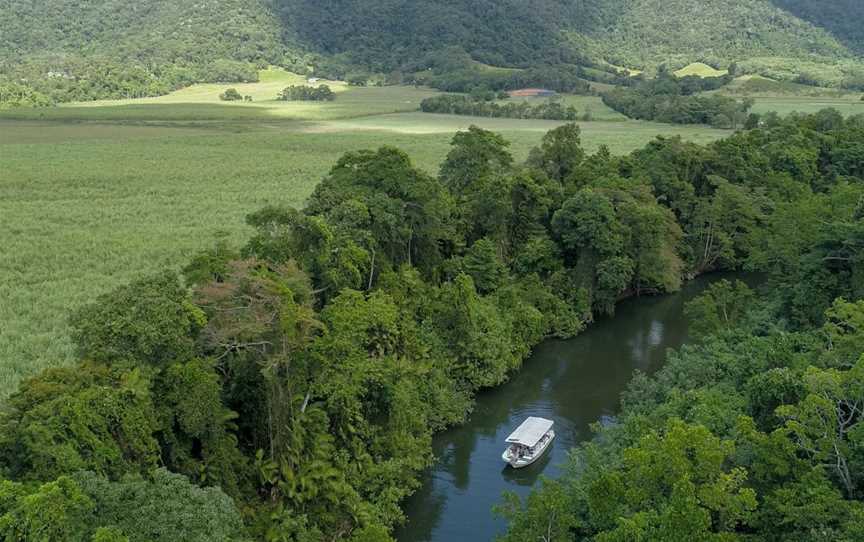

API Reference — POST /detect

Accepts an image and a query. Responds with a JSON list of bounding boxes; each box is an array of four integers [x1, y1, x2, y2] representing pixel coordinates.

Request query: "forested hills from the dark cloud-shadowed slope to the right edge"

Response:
[[282, 0, 861, 68]]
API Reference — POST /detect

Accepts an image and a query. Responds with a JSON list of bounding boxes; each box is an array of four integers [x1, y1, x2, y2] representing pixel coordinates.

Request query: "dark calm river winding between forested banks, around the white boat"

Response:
[[396, 275, 729, 542]]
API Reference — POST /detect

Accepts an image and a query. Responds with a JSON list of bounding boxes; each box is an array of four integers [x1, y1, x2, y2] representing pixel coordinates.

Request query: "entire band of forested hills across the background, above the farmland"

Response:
[[0, 0, 864, 100]]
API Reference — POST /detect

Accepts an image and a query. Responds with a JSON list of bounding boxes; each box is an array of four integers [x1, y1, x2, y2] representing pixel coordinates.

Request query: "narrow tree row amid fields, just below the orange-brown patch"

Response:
[[420, 94, 579, 121]]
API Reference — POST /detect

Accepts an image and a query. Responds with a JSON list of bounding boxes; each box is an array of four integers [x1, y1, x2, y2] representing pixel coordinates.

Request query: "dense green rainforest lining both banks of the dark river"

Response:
[[0, 110, 864, 542]]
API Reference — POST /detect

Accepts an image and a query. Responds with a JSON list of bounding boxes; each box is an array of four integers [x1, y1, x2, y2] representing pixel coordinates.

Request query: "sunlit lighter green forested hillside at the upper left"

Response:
[[0, 0, 295, 101]]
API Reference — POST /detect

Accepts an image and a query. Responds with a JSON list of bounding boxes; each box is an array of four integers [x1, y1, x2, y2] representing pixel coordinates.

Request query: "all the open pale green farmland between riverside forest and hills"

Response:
[[0, 69, 764, 397]]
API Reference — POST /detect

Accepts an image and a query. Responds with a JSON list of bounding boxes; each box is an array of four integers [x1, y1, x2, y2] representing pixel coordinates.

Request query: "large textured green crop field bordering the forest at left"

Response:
[[0, 123, 447, 395]]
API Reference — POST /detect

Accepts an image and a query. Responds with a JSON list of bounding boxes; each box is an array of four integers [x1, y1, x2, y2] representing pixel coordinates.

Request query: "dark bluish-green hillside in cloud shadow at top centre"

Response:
[[279, 0, 580, 71]]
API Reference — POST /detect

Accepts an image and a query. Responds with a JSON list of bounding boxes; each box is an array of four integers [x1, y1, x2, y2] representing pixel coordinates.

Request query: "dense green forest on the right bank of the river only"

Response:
[[499, 171, 864, 542]]
